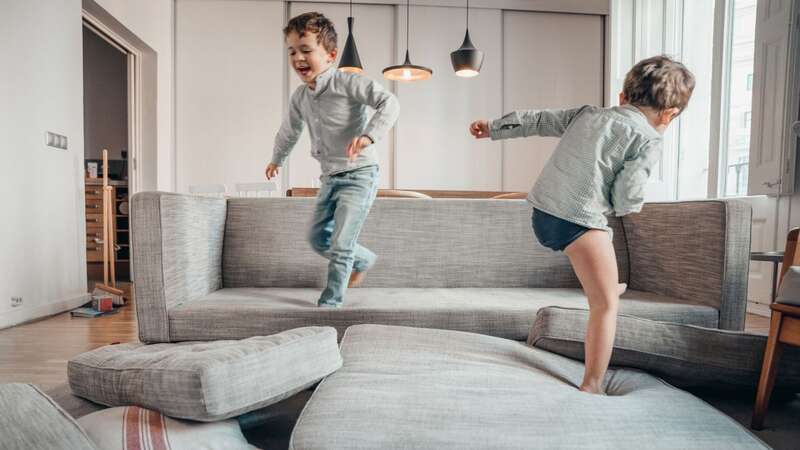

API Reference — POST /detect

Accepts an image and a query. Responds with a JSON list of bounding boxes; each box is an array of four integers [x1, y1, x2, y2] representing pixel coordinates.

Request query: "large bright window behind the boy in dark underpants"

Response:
[[611, 0, 757, 201]]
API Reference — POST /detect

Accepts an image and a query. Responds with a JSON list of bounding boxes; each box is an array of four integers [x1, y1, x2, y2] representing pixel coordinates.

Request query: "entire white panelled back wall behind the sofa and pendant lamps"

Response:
[[176, 0, 607, 191]]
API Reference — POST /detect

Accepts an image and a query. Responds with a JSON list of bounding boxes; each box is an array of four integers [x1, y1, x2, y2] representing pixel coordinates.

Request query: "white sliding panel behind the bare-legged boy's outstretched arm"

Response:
[[502, 11, 605, 191]]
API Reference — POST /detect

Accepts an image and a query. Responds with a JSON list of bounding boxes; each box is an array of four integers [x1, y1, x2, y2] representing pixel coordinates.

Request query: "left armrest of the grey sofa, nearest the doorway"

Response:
[[130, 192, 226, 343]]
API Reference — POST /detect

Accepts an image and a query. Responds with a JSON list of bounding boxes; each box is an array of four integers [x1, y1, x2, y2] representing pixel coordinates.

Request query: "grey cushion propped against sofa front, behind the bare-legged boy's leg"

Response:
[[528, 308, 800, 391]]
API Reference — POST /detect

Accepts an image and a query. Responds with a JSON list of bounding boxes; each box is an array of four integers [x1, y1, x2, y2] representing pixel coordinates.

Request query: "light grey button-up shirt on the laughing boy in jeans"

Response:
[[272, 67, 400, 175]]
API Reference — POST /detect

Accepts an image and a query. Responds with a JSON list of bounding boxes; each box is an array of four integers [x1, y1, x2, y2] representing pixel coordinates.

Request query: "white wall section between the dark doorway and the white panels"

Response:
[[95, 0, 175, 191]]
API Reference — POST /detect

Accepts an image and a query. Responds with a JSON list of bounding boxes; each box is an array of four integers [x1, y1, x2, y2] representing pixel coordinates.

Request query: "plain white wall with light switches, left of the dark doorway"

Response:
[[0, 0, 86, 327]]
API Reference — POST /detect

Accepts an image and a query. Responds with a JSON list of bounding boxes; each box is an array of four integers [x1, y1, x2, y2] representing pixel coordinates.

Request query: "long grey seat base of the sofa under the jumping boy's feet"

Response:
[[168, 288, 719, 341]]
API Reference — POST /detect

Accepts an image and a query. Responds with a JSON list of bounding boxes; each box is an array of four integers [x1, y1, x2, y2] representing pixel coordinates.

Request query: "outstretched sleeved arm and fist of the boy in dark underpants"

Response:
[[470, 106, 591, 141]]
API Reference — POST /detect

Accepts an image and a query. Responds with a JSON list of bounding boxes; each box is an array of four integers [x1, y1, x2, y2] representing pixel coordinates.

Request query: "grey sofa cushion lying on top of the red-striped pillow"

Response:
[[68, 327, 342, 421]]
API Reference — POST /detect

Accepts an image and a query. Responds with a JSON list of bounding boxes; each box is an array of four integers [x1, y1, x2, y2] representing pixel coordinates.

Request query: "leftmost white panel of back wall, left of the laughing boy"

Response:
[[175, 0, 284, 192]]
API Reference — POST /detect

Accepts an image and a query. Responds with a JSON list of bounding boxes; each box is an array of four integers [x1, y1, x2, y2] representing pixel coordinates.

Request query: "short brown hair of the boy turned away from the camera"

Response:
[[622, 55, 695, 113]]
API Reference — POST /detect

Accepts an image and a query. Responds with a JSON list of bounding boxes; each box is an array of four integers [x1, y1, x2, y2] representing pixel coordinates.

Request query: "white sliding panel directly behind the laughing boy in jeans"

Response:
[[290, 2, 402, 188]]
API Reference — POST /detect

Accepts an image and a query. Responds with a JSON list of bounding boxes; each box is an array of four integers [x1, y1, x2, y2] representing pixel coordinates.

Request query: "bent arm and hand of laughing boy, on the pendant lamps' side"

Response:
[[346, 74, 400, 158]]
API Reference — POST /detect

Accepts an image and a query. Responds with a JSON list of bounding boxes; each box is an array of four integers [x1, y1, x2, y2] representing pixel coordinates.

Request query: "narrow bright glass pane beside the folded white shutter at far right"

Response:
[[719, 0, 756, 196]]
